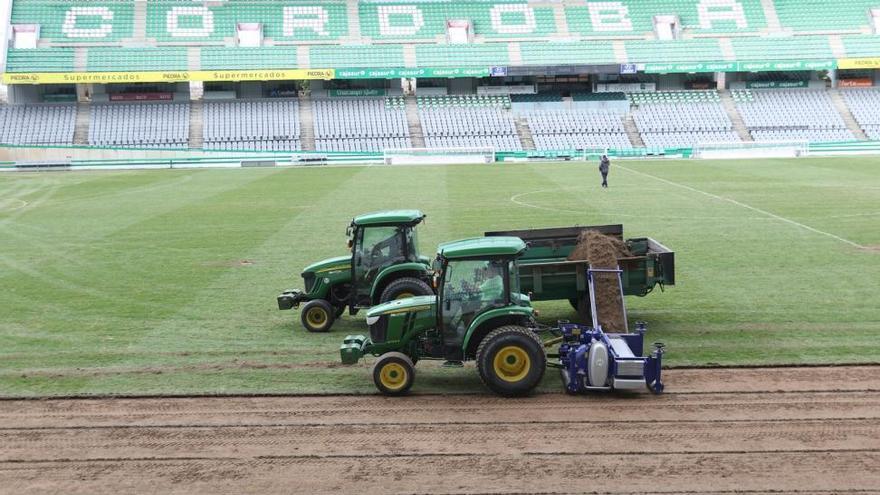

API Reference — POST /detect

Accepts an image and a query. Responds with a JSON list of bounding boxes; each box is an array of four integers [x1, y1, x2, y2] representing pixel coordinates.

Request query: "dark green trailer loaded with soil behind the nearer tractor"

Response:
[[485, 224, 675, 321]]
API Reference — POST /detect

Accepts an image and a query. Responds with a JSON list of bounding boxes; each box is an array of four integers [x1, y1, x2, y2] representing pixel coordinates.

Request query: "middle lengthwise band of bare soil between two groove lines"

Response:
[[0, 420, 880, 463]]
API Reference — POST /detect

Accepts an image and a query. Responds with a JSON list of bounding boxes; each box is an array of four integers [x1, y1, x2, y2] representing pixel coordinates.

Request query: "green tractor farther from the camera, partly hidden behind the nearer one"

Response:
[[278, 210, 434, 332]]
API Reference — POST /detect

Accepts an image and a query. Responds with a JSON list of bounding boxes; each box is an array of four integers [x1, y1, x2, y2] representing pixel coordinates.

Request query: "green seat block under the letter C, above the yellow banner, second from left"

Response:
[[86, 46, 189, 72]]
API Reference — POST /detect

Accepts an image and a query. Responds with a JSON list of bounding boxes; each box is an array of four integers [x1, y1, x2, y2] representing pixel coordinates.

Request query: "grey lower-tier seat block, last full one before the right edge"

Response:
[[733, 89, 855, 141]]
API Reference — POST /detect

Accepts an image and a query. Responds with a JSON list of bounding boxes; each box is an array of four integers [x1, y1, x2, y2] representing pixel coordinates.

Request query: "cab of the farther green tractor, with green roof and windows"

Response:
[[347, 210, 426, 307]]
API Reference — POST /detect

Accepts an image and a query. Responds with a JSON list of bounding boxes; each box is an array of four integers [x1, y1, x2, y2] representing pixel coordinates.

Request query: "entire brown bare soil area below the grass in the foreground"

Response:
[[0, 366, 880, 494]]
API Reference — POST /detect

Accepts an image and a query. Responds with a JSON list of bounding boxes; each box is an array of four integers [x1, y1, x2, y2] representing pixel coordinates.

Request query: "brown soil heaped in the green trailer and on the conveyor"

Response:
[[568, 230, 632, 332]]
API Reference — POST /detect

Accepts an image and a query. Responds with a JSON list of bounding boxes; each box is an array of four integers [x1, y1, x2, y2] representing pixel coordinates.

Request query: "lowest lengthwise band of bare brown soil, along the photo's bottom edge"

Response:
[[0, 451, 880, 494]]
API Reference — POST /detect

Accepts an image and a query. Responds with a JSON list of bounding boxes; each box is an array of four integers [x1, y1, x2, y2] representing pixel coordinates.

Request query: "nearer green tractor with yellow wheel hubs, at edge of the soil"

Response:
[[340, 237, 547, 396]]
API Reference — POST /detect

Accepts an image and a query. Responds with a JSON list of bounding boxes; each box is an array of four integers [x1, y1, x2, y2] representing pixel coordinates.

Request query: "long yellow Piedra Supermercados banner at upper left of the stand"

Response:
[[3, 69, 336, 84]]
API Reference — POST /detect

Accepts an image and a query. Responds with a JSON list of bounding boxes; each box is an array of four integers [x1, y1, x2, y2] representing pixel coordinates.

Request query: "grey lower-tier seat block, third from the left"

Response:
[[203, 99, 301, 151]]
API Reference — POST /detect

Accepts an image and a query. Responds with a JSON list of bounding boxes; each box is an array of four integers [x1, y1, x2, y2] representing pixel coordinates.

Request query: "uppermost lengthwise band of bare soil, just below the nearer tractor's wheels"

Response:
[[0, 392, 880, 430]]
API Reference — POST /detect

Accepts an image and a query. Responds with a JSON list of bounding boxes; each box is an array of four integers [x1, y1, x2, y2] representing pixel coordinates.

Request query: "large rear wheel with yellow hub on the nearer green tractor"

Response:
[[477, 325, 547, 397]]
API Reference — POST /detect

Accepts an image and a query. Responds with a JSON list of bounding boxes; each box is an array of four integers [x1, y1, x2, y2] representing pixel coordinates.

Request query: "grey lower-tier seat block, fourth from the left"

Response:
[[313, 98, 412, 151]]
